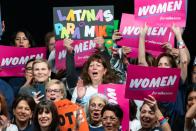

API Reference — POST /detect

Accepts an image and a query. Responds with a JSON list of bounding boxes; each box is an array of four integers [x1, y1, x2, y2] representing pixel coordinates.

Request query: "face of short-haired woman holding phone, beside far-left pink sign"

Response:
[[33, 62, 51, 82]]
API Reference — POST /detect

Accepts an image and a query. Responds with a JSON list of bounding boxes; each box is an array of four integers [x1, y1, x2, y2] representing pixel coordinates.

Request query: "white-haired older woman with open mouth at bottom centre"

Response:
[[87, 94, 108, 131]]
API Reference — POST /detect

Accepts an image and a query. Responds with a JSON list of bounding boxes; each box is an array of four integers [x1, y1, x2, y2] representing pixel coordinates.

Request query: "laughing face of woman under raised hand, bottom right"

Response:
[[140, 104, 157, 129]]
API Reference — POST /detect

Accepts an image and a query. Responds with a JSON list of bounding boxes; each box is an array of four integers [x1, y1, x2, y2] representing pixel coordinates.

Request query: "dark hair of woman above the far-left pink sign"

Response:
[[11, 29, 35, 47]]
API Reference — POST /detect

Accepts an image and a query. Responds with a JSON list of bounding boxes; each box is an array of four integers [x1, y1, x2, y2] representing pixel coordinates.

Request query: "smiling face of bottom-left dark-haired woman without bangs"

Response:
[[13, 100, 32, 122]]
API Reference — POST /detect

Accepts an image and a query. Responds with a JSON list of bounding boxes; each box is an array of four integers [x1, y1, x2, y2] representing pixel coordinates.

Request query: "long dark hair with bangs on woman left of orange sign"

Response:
[[33, 100, 59, 131]]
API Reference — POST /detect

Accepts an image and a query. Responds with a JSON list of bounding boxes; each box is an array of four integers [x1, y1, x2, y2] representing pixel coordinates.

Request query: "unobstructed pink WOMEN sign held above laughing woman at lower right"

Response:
[[125, 65, 180, 102]]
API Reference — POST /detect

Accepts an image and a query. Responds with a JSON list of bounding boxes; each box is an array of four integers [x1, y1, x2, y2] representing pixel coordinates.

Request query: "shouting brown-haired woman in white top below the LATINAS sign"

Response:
[[72, 54, 118, 106]]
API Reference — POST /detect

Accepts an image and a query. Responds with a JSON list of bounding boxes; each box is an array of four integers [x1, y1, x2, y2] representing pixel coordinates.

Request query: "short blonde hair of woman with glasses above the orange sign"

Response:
[[46, 79, 67, 98]]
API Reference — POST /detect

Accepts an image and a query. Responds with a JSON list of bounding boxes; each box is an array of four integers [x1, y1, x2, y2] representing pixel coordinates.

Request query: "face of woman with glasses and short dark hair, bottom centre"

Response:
[[102, 110, 120, 131]]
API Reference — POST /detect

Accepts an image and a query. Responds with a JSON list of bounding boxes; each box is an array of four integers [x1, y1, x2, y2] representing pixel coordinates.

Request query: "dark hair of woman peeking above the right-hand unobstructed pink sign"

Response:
[[156, 53, 177, 68]]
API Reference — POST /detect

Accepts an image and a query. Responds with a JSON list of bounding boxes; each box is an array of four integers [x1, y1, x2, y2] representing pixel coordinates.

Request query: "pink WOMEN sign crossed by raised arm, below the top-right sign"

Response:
[[117, 13, 174, 57]]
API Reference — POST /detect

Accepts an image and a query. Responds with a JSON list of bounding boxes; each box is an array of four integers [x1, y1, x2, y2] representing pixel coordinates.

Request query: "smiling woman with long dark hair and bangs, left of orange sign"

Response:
[[33, 100, 59, 131]]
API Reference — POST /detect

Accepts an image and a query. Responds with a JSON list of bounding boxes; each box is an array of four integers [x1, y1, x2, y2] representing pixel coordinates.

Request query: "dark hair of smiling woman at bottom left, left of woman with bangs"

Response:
[[12, 94, 36, 112]]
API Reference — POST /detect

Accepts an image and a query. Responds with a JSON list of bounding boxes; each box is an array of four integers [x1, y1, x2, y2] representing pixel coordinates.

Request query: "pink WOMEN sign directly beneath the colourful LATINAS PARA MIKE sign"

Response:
[[55, 40, 97, 70]]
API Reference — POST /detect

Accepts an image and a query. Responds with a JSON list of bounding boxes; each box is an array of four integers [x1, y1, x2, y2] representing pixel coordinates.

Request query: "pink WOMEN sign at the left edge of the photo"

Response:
[[0, 46, 46, 76]]
